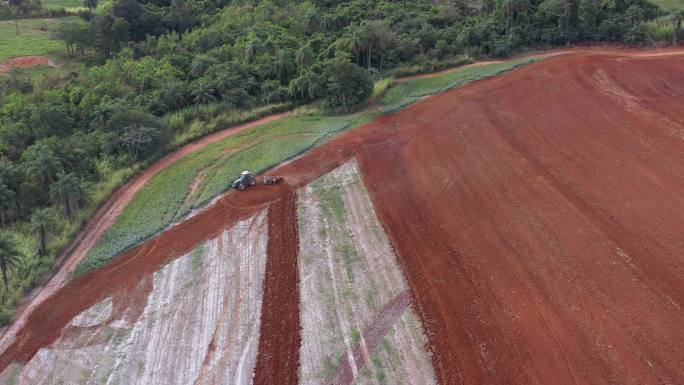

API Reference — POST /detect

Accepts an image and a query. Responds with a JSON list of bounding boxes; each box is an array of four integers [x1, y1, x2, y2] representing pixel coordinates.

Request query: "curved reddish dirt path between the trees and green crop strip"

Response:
[[0, 112, 289, 351]]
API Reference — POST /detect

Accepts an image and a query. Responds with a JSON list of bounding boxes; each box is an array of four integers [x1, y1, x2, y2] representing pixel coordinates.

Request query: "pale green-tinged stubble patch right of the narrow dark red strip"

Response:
[[297, 161, 435, 384]]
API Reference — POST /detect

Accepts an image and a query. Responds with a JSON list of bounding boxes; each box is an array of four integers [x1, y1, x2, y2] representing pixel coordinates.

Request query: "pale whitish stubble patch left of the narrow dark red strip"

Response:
[[0, 211, 268, 385]]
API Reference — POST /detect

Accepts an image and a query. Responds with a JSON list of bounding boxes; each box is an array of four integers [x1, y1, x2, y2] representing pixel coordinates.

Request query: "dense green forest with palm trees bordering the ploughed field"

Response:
[[0, 0, 682, 323]]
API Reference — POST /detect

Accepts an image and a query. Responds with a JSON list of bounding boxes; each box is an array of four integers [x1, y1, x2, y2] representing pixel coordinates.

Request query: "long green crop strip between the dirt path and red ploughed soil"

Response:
[[76, 60, 531, 274]]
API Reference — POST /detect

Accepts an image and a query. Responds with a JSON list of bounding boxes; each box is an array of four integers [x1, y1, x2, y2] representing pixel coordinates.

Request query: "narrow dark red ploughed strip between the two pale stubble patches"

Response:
[[254, 189, 301, 385]]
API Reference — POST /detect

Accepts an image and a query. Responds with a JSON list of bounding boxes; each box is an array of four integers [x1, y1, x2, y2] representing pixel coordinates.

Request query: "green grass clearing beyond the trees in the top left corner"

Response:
[[0, 17, 76, 62]]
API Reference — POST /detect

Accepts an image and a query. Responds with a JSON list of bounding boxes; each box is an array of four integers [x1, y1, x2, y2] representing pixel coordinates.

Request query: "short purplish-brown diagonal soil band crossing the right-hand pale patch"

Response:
[[328, 290, 411, 385]]
